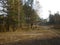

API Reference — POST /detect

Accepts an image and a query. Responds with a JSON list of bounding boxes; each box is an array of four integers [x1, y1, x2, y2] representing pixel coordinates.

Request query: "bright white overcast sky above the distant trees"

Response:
[[37, 0, 60, 19]]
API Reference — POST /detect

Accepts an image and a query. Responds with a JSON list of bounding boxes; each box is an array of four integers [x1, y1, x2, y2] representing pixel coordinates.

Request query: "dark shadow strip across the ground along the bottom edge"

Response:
[[3, 37, 60, 45]]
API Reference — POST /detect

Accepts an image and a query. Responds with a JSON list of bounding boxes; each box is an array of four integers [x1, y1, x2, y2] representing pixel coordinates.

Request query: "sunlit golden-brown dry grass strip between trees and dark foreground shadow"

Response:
[[0, 30, 58, 44]]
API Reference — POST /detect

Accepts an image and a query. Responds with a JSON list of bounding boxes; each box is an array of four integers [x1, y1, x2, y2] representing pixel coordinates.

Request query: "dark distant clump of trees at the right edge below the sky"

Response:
[[49, 12, 60, 29]]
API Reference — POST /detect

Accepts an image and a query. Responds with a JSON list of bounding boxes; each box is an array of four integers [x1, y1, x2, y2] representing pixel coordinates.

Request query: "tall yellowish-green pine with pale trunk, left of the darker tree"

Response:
[[8, 0, 25, 28]]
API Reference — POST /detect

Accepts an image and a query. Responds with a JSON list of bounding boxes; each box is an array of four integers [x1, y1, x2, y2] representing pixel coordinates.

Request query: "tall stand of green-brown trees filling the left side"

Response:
[[0, 0, 39, 32]]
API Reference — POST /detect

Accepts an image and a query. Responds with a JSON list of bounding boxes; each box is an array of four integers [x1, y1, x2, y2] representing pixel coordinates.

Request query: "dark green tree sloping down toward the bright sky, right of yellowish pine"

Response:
[[23, 0, 39, 28]]
